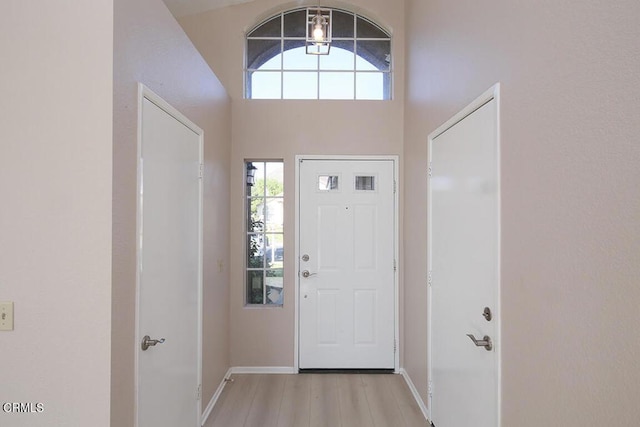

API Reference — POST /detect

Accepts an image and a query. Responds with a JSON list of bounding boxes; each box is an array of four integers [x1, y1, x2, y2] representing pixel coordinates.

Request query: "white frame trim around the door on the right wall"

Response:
[[427, 83, 502, 427]]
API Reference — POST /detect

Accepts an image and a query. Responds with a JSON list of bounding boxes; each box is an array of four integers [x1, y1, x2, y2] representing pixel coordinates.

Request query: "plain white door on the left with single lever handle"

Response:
[[137, 94, 202, 427]]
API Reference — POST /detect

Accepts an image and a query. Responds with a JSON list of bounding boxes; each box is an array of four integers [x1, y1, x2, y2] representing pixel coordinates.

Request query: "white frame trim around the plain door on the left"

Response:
[[133, 82, 204, 427]]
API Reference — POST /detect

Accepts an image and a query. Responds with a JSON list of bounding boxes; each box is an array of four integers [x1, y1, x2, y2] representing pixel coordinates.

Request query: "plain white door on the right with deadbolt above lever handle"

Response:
[[429, 99, 500, 427]]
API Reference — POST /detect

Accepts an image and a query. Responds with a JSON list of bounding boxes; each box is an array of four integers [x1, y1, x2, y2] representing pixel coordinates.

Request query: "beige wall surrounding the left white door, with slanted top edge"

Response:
[[111, 0, 231, 427]]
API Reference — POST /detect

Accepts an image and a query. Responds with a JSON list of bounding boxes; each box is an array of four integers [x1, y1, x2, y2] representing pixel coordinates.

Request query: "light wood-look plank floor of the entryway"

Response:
[[203, 374, 428, 427]]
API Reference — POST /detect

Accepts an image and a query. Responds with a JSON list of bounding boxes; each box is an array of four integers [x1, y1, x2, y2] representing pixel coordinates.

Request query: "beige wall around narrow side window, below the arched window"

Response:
[[230, 100, 402, 366]]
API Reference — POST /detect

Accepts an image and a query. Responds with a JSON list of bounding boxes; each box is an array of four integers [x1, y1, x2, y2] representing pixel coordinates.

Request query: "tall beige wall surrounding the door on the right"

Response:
[[405, 0, 640, 427]]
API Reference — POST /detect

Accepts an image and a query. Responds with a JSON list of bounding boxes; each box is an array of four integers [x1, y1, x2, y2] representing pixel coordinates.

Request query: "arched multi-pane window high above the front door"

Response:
[[245, 9, 391, 100]]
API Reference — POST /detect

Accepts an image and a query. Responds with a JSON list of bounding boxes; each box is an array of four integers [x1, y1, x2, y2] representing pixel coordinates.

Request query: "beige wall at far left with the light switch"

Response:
[[0, 0, 113, 427]]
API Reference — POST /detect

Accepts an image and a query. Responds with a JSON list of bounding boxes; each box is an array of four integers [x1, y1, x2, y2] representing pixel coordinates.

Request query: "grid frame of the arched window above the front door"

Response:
[[243, 7, 394, 101]]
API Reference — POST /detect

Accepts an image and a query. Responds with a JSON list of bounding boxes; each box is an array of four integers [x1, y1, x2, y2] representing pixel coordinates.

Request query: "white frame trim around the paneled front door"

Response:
[[293, 154, 402, 373]]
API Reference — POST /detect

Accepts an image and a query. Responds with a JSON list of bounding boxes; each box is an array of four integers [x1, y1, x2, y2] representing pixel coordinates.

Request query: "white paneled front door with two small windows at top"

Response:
[[298, 159, 395, 369]]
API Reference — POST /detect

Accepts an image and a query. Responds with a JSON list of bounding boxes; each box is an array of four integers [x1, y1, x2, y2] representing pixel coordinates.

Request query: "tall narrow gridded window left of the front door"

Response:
[[245, 161, 284, 306]]
